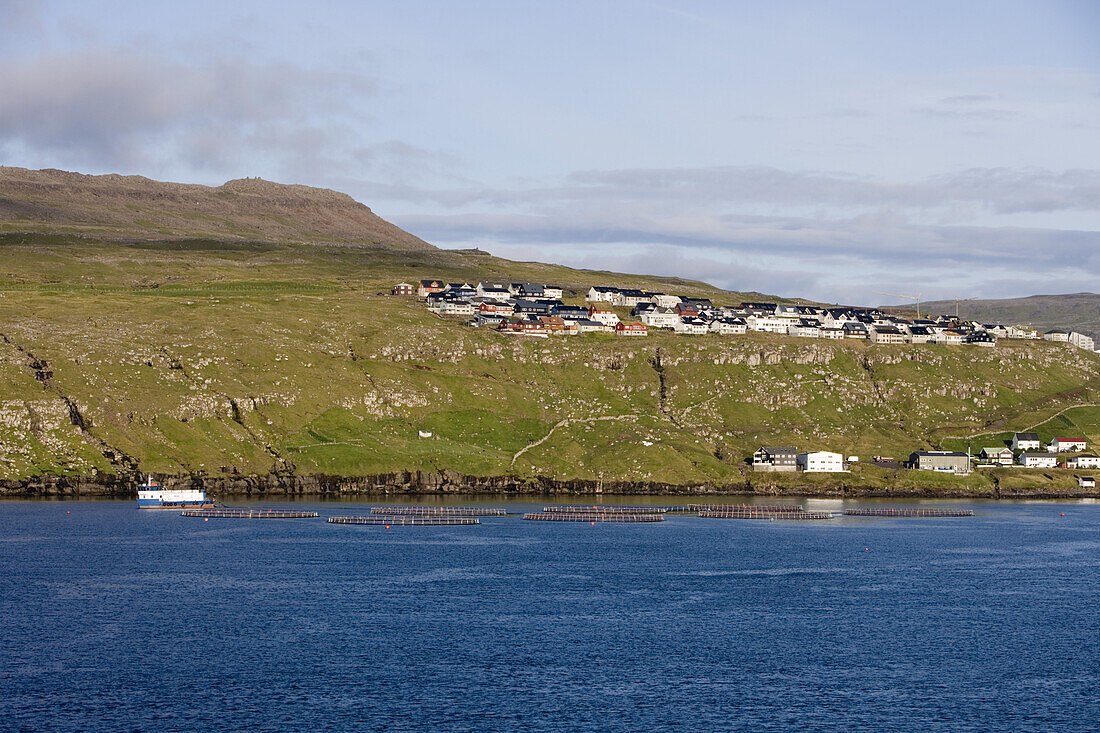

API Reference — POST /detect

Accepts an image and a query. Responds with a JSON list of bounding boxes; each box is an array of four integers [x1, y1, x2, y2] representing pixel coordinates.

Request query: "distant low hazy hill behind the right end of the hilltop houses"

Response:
[[921, 293, 1100, 339]]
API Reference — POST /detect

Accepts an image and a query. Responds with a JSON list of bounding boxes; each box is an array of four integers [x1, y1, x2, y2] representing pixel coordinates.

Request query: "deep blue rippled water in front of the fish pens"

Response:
[[0, 502, 1100, 731]]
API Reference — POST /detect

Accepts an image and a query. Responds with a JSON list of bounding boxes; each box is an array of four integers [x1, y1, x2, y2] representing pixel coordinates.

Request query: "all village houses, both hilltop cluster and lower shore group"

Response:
[[402, 280, 1100, 488]]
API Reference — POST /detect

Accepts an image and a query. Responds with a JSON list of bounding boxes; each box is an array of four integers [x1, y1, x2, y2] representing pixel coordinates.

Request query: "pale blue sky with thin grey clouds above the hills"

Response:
[[0, 0, 1100, 304]]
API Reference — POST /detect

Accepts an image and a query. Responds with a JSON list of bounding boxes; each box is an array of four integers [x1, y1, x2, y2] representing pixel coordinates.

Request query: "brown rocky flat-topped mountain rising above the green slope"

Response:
[[0, 166, 436, 250]]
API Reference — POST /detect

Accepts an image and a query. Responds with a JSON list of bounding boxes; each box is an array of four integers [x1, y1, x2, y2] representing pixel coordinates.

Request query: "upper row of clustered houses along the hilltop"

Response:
[[393, 280, 1096, 351]]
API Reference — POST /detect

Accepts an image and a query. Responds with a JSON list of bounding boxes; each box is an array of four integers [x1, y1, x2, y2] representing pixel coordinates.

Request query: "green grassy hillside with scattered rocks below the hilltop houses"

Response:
[[0, 234, 1100, 490]]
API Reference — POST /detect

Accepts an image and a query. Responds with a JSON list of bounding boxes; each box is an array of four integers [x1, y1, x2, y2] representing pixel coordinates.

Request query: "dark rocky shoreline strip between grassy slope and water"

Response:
[[0, 470, 1100, 500]]
